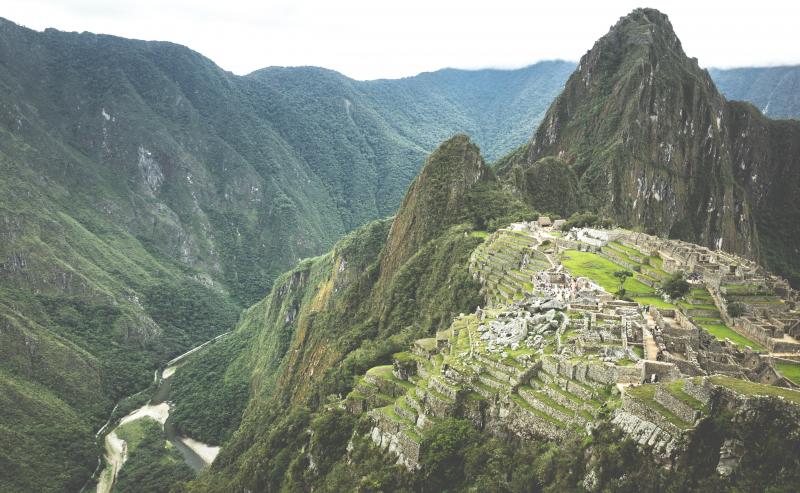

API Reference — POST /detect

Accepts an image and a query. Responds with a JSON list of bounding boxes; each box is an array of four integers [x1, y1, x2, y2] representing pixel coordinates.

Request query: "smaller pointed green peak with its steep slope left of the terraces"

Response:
[[175, 136, 534, 491]]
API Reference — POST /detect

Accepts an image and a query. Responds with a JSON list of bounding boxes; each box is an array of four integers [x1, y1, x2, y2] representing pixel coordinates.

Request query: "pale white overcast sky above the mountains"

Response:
[[0, 0, 800, 79]]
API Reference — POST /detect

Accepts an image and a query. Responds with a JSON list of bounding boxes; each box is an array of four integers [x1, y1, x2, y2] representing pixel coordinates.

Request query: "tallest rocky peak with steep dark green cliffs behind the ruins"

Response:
[[498, 9, 800, 284]]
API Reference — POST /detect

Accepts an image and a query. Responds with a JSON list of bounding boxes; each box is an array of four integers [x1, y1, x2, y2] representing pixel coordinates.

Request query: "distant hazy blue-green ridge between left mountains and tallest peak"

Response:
[[359, 61, 575, 161]]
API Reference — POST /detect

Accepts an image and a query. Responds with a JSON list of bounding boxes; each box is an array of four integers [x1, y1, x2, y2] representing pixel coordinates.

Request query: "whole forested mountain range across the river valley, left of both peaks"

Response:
[[0, 14, 571, 491]]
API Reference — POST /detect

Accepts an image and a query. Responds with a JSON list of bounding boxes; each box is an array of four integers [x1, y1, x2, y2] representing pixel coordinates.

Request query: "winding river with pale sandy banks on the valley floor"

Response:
[[81, 332, 230, 493]]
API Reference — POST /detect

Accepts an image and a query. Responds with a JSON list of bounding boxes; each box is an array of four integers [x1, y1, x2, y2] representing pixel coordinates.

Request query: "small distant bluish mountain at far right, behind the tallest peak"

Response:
[[708, 65, 800, 119]]
